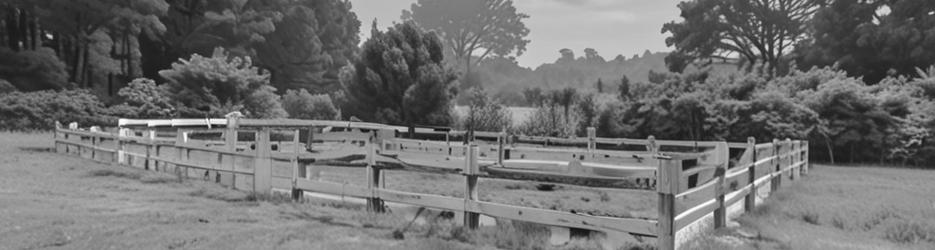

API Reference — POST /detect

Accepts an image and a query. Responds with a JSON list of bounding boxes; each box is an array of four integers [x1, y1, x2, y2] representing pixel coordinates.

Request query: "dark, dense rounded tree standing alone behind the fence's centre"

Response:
[[340, 22, 456, 125]]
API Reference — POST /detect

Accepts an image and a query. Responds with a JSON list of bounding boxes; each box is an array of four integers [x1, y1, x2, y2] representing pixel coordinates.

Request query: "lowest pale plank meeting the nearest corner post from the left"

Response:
[[467, 201, 656, 236]]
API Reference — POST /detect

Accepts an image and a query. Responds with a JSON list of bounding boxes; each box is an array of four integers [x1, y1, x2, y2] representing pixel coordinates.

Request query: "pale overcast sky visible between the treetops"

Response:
[[351, 0, 679, 68]]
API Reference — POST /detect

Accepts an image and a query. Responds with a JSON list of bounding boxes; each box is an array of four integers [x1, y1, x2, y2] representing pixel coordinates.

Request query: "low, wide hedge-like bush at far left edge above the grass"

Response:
[[0, 90, 117, 130]]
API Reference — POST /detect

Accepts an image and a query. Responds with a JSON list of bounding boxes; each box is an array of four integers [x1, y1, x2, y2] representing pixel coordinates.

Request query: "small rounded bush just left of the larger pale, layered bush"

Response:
[[112, 78, 177, 119]]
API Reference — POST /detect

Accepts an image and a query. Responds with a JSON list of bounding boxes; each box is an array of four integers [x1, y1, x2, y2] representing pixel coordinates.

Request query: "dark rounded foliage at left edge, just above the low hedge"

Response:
[[0, 47, 68, 91]]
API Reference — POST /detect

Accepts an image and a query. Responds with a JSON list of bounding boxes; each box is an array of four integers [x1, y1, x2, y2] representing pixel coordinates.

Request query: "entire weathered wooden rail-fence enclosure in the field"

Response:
[[55, 118, 809, 249]]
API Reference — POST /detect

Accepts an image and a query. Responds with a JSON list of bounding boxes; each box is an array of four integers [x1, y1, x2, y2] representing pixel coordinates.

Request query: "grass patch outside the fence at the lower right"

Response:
[[688, 165, 935, 249]]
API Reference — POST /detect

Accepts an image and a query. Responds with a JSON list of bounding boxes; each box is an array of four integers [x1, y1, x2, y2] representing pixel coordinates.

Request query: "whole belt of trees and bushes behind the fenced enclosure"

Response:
[[0, 0, 935, 166]]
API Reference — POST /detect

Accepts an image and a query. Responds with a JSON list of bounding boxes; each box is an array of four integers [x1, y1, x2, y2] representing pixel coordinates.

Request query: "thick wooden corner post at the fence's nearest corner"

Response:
[[650, 154, 682, 250]]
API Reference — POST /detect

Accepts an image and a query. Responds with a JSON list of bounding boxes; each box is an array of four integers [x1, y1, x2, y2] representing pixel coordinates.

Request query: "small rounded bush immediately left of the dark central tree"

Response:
[[282, 89, 341, 120]]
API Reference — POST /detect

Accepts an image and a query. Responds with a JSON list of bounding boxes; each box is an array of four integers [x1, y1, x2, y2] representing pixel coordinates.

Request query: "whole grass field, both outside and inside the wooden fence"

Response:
[[0, 133, 935, 249]]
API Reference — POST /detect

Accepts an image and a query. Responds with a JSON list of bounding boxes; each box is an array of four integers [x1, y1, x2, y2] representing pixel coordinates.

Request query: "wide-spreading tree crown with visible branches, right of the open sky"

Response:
[[662, 0, 822, 74]]
